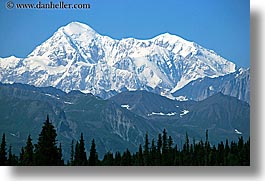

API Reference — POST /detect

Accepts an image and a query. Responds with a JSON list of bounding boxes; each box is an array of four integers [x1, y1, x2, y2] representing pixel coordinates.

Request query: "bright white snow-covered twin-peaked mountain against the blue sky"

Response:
[[0, 22, 236, 98]]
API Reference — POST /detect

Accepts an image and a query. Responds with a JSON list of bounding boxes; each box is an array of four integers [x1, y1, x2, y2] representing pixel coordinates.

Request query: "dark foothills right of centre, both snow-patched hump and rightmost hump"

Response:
[[108, 91, 250, 145]]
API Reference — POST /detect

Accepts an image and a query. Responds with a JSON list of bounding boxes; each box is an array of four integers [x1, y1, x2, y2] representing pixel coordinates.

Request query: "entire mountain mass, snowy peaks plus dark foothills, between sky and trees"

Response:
[[0, 22, 250, 158]]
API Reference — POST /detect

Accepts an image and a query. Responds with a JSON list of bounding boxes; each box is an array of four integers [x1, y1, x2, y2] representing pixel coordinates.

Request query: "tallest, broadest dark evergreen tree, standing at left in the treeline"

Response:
[[35, 116, 59, 166]]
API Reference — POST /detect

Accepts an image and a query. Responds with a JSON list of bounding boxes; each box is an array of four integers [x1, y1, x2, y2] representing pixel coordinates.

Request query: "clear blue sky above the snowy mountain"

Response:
[[0, 0, 250, 67]]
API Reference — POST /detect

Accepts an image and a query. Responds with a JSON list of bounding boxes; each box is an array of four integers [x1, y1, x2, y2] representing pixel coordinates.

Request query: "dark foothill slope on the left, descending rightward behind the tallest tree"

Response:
[[0, 84, 157, 158]]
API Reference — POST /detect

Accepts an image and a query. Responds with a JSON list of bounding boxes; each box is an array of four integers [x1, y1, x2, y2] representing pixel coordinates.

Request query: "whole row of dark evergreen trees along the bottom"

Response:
[[0, 116, 250, 166]]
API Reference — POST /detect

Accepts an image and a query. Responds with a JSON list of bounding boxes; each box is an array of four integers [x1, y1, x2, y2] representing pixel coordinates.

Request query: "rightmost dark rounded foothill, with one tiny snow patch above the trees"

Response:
[[174, 93, 250, 142]]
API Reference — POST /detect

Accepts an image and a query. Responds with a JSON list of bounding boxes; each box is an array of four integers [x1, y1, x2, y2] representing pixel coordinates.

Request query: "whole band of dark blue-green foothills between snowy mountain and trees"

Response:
[[0, 84, 250, 158]]
